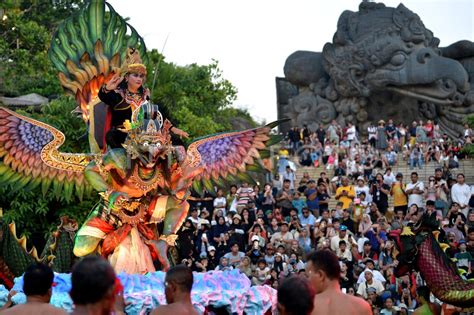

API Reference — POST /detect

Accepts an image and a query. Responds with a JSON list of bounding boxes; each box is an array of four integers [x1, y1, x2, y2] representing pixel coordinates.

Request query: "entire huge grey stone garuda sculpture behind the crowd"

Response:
[[277, 2, 474, 137]]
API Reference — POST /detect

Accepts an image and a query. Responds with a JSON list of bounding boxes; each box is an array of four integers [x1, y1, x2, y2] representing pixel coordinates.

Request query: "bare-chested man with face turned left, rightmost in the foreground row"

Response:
[[306, 250, 372, 315]]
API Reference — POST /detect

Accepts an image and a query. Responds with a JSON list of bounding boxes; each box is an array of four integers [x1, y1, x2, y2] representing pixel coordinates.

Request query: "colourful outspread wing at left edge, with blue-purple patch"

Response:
[[0, 107, 93, 200]]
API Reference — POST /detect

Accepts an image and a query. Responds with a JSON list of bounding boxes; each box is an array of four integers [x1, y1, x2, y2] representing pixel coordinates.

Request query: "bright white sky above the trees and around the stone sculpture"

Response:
[[109, 0, 474, 122]]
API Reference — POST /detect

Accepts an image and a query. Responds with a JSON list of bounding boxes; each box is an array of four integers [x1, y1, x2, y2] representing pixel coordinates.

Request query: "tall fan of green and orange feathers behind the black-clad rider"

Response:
[[48, 0, 147, 153]]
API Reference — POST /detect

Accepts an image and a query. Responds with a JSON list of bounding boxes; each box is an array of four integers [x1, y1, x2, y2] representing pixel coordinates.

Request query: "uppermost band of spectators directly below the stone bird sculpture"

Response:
[[286, 120, 473, 176]]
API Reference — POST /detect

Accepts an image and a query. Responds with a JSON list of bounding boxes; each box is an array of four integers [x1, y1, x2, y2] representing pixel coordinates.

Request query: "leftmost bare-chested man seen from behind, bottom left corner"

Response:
[[0, 264, 67, 315]]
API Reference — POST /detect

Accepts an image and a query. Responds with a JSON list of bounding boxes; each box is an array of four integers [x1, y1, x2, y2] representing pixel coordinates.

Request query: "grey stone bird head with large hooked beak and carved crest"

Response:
[[323, 3, 469, 105]]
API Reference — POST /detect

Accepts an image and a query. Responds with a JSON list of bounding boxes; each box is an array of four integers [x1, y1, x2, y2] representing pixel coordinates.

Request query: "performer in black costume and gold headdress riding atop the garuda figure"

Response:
[[98, 48, 188, 148]]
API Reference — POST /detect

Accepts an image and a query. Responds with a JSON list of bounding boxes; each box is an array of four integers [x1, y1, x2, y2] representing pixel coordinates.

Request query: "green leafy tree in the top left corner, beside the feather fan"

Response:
[[0, 0, 83, 96]]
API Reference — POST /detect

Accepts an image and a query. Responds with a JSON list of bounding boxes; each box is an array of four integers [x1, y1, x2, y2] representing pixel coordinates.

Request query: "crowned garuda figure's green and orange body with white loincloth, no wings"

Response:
[[74, 104, 199, 273]]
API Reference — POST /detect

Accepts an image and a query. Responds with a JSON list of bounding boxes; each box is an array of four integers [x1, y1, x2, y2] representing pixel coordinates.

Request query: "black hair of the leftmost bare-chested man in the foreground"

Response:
[[23, 264, 54, 296]]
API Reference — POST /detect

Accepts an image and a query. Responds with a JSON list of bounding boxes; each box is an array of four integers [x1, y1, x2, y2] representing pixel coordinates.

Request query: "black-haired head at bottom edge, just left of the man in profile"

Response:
[[277, 276, 315, 315]]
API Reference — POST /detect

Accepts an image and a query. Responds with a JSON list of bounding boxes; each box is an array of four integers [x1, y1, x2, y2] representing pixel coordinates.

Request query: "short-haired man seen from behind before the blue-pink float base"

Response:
[[151, 265, 198, 315]]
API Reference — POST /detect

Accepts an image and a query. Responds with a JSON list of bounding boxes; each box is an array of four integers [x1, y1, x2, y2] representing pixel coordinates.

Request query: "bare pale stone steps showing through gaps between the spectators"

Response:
[[294, 154, 474, 209]]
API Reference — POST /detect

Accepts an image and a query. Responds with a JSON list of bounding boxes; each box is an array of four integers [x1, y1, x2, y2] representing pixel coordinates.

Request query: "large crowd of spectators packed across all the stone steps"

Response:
[[179, 121, 474, 314]]
